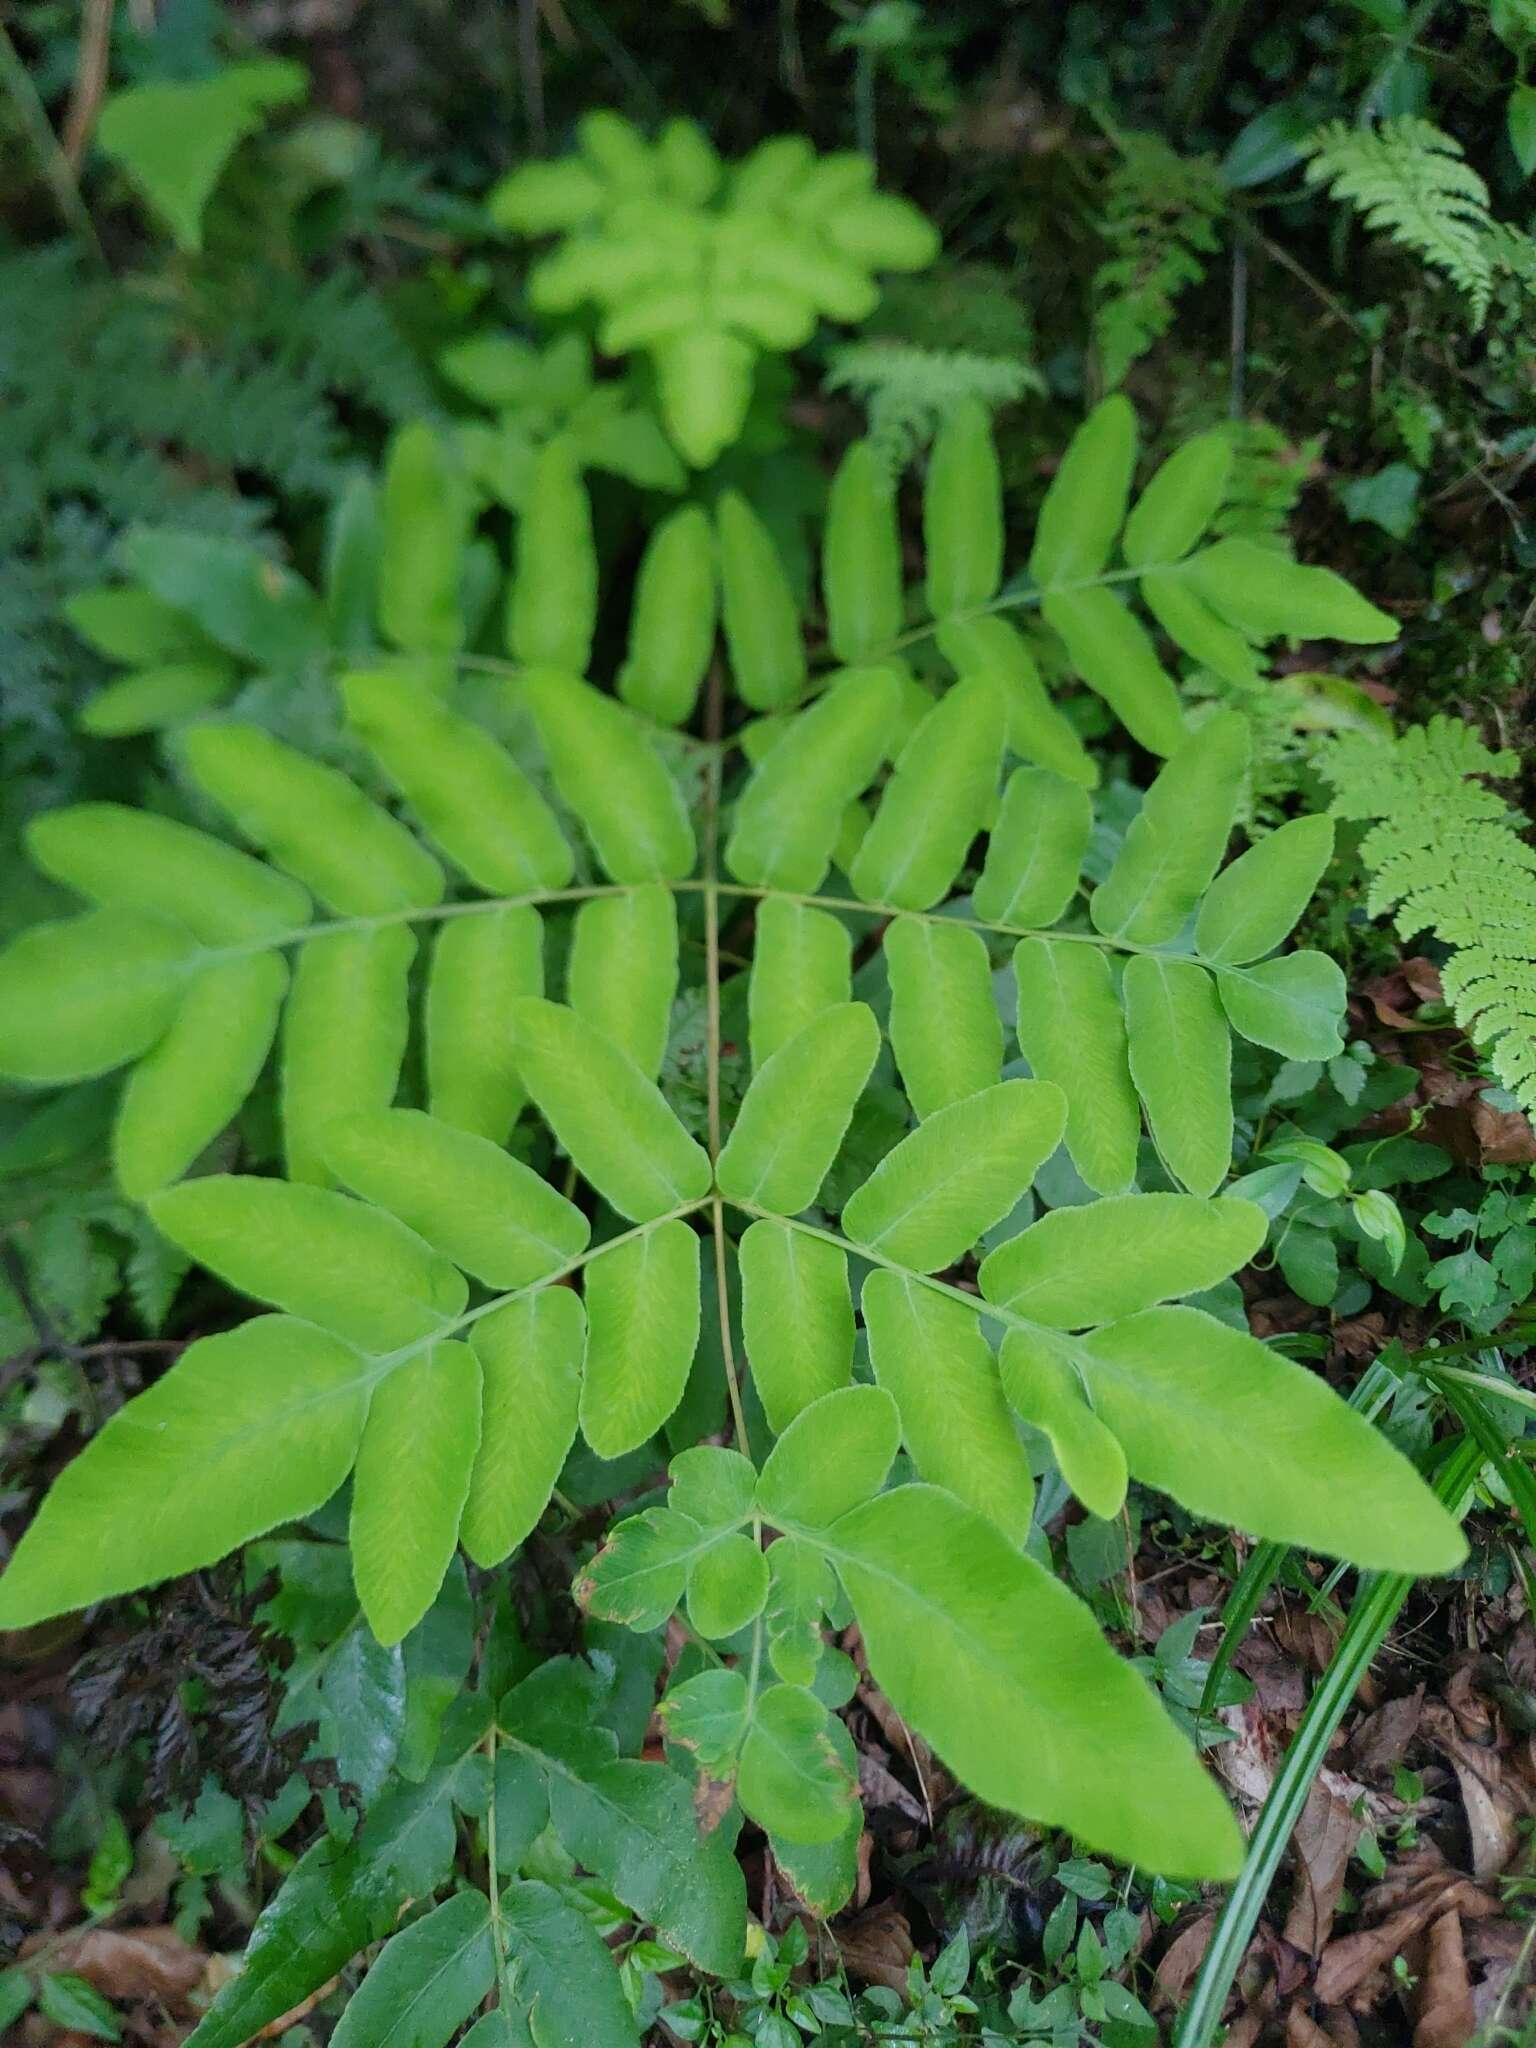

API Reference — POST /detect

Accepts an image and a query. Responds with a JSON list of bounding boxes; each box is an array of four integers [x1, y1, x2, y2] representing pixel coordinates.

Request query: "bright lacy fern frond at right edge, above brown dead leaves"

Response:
[[1321, 717, 1536, 1114]]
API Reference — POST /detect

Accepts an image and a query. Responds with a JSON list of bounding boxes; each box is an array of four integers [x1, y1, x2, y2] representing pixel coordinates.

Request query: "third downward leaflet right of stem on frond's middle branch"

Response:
[[1014, 938, 1141, 1194]]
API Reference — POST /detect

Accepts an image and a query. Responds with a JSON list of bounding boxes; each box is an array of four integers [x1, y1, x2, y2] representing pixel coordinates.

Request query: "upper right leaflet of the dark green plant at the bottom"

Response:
[[549, 1759, 748, 1976]]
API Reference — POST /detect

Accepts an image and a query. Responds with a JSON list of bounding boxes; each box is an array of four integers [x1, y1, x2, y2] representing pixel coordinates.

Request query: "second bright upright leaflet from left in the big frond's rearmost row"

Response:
[[506, 434, 598, 675]]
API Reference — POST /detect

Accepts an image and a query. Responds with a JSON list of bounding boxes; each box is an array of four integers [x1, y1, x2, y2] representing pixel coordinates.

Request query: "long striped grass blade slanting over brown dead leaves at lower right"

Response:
[[1174, 1434, 1483, 2048]]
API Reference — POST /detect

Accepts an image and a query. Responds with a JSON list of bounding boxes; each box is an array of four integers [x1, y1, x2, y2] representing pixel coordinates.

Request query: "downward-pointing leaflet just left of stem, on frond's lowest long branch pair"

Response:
[[582, 1219, 698, 1458]]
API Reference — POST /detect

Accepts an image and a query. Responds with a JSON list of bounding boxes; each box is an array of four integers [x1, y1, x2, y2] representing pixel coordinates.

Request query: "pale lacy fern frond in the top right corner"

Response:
[[1303, 115, 1507, 326]]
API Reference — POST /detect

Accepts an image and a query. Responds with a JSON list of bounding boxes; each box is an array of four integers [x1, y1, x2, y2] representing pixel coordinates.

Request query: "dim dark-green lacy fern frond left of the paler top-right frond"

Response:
[[1094, 135, 1227, 387]]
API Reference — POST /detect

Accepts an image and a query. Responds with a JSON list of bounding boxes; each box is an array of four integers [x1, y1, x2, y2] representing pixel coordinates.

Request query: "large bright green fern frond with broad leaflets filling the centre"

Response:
[[0, 399, 1462, 2048]]
